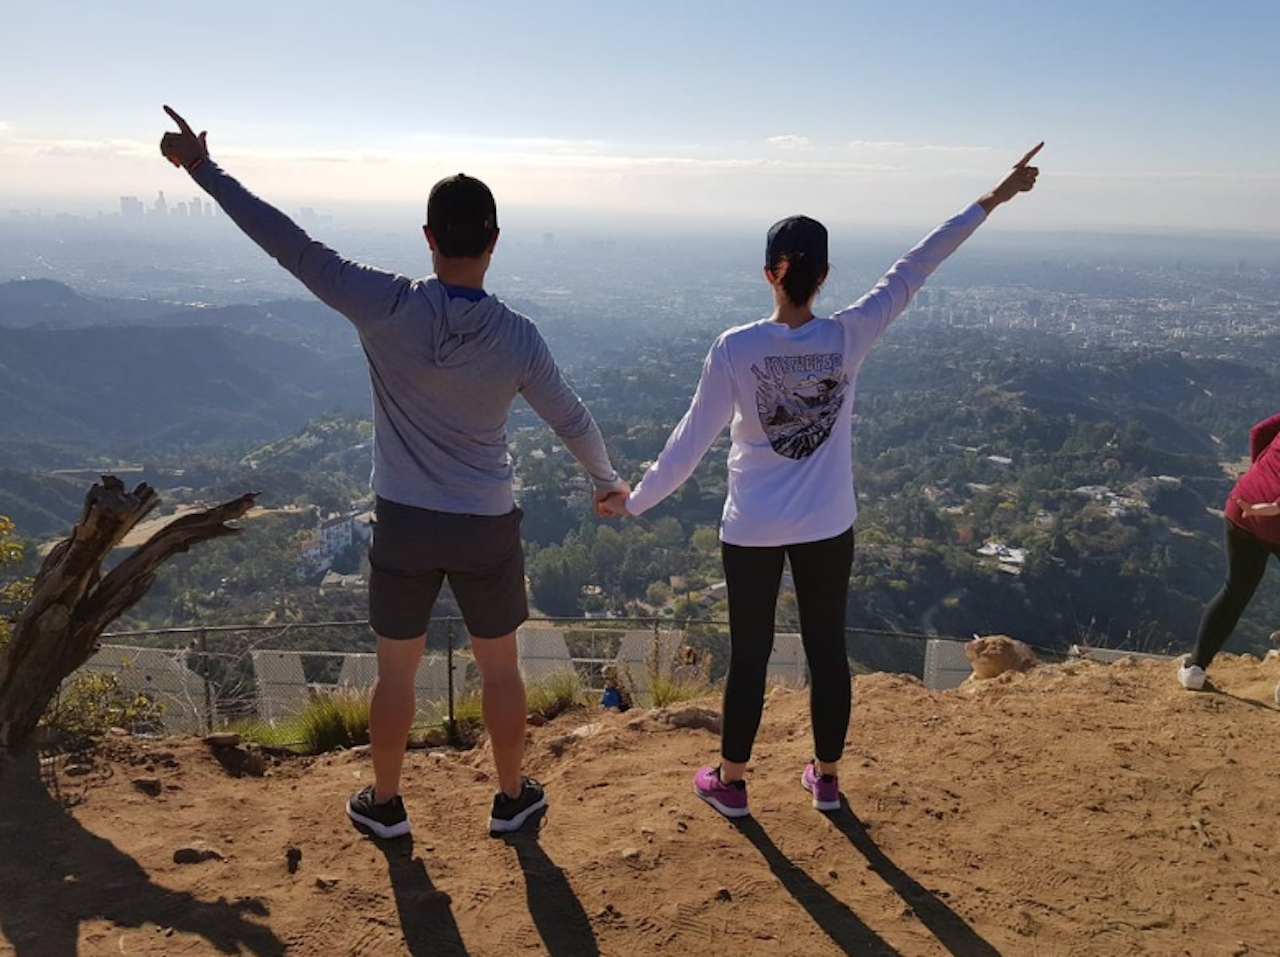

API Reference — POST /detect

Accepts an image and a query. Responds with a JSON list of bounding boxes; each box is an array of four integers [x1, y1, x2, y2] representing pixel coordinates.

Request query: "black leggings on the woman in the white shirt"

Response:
[[721, 528, 854, 764]]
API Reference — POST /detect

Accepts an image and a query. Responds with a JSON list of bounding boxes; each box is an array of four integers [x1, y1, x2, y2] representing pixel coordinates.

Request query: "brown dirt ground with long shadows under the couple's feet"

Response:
[[0, 656, 1280, 957]]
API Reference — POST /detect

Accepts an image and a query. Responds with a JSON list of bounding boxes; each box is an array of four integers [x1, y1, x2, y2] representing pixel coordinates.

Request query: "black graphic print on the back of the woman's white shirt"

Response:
[[751, 352, 849, 459]]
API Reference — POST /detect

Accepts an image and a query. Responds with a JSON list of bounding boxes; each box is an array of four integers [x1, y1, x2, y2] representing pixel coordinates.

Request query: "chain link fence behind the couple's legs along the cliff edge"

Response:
[[82, 618, 1061, 733]]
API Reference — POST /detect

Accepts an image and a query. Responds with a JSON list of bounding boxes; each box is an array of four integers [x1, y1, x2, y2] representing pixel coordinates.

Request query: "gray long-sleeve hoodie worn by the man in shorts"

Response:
[[191, 160, 625, 516]]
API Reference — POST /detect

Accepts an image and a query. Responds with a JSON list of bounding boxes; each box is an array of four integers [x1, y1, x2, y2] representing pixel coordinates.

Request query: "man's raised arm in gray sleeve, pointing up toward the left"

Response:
[[160, 106, 410, 326]]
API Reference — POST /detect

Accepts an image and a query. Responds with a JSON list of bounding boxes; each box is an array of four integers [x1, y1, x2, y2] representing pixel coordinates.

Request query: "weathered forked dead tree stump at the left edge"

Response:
[[0, 476, 256, 751]]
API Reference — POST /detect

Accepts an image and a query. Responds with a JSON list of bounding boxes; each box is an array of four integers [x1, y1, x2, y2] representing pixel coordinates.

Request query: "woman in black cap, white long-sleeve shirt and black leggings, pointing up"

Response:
[[602, 145, 1043, 818]]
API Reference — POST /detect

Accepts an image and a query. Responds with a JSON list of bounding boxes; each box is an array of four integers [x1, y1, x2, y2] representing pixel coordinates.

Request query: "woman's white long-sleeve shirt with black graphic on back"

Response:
[[627, 203, 987, 546]]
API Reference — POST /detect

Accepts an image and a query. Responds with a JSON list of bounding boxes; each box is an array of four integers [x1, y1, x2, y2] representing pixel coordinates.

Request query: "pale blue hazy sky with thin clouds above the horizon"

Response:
[[0, 0, 1280, 234]]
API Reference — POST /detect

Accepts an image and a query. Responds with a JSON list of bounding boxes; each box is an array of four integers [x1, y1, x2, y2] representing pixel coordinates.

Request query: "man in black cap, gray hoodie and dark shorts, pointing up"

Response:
[[160, 106, 628, 837]]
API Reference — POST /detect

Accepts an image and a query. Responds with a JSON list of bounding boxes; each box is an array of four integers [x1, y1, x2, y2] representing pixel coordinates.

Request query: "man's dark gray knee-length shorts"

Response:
[[369, 498, 529, 638]]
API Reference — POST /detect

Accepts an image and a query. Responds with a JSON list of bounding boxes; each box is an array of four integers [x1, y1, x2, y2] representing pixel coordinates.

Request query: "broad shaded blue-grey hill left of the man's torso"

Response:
[[0, 326, 369, 455]]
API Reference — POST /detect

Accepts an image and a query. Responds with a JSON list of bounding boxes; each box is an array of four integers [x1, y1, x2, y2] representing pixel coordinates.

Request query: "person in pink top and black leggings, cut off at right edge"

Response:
[[1178, 413, 1280, 702]]
